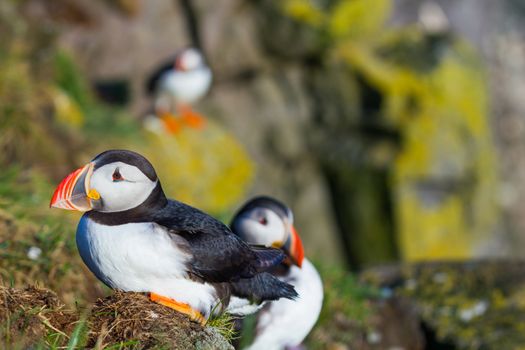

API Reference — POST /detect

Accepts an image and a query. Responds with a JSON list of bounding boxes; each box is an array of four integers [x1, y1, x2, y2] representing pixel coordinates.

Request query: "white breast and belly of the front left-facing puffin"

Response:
[[76, 216, 217, 316]]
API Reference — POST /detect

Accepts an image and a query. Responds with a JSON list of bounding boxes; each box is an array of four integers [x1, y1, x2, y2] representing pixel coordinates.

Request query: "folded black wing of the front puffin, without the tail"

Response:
[[154, 201, 285, 282]]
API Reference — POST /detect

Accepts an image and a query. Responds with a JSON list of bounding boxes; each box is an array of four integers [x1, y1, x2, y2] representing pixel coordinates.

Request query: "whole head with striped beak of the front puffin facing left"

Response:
[[50, 150, 160, 213]]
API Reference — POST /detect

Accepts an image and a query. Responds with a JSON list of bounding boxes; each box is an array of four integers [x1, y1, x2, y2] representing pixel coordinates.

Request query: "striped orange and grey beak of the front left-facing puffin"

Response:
[[49, 163, 100, 211]]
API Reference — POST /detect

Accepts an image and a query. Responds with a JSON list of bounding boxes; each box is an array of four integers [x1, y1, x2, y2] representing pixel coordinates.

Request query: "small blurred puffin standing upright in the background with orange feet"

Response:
[[146, 47, 212, 133]]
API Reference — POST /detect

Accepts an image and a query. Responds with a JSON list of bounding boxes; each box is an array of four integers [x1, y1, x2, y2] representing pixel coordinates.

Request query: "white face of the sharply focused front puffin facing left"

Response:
[[89, 162, 157, 212]]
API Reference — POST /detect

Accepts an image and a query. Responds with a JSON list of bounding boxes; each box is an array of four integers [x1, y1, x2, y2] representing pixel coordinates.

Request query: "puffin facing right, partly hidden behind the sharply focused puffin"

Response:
[[230, 196, 323, 350]]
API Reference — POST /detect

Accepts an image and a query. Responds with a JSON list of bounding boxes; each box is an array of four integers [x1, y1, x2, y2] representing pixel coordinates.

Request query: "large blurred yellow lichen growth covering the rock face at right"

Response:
[[282, 0, 497, 260]]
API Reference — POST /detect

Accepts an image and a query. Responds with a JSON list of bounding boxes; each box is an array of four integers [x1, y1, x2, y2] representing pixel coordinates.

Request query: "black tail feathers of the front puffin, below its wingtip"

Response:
[[231, 272, 299, 303]]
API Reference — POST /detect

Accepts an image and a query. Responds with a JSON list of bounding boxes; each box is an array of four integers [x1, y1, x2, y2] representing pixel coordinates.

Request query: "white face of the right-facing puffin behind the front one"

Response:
[[234, 207, 288, 247]]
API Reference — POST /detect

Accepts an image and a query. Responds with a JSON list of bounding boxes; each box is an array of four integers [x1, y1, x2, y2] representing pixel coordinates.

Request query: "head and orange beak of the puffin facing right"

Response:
[[230, 196, 304, 267]]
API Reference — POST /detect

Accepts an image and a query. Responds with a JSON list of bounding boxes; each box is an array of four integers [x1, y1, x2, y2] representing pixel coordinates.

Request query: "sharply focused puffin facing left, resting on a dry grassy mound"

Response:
[[50, 150, 297, 324]]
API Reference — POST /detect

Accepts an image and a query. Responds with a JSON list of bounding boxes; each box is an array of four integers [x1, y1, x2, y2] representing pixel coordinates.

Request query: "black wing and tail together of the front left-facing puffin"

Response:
[[154, 200, 297, 302]]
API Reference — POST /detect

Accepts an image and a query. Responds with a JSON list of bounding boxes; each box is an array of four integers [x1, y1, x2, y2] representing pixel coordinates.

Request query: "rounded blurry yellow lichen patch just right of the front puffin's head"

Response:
[[139, 121, 254, 213]]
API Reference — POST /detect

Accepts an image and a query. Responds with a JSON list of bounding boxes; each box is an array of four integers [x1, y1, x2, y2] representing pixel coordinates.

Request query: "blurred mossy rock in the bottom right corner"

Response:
[[362, 260, 525, 349]]
